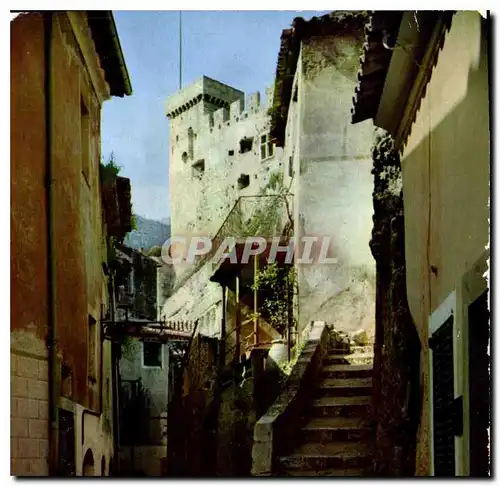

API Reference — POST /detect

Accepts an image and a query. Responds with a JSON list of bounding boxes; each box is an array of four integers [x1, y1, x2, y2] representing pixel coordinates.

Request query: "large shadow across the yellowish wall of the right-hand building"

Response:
[[398, 20, 490, 475]]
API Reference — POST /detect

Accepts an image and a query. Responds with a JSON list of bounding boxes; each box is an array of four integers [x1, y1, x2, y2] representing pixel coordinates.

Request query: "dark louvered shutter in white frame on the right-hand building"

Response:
[[429, 316, 455, 477]]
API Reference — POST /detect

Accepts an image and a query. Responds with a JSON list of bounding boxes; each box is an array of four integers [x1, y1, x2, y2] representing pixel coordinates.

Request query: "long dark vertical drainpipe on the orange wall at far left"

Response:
[[43, 12, 61, 476]]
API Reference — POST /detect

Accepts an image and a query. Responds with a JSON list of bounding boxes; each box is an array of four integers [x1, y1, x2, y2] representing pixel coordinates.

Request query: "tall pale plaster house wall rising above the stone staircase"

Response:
[[292, 33, 375, 334]]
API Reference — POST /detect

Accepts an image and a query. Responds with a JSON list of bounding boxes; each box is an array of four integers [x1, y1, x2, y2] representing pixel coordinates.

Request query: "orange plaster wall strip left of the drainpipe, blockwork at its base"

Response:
[[10, 14, 49, 476]]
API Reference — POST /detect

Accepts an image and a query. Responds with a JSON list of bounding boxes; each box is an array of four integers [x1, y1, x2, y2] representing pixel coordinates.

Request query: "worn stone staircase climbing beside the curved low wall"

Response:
[[277, 343, 373, 477]]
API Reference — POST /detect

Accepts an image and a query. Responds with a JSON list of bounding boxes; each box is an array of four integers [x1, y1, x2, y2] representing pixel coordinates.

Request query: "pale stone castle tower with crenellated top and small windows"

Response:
[[166, 76, 282, 237]]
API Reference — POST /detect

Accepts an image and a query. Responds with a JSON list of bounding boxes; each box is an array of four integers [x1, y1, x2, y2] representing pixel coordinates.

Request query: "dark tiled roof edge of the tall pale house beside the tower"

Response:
[[271, 11, 369, 147]]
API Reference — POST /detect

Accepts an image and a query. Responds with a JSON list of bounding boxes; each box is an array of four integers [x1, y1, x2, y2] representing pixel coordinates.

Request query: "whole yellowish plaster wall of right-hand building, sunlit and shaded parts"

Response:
[[402, 12, 490, 475]]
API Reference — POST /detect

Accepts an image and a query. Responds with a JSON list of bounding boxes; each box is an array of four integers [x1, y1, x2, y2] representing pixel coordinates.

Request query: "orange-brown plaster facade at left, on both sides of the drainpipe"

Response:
[[11, 12, 112, 475]]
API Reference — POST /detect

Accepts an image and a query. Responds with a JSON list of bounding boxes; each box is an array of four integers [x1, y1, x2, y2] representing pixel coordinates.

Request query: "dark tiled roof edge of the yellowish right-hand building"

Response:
[[351, 11, 404, 123]]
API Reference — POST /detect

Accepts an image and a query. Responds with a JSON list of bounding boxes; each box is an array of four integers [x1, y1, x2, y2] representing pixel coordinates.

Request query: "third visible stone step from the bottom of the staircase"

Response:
[[300, 417, 371, 444]]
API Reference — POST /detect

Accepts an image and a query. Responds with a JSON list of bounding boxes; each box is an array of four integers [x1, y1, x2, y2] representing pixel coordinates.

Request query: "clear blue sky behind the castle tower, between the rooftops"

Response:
[[102, 11, 324, 219]]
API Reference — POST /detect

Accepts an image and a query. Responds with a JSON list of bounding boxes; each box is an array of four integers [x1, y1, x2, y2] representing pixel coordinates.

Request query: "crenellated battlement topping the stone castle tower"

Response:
[[166, 76, 274, 138]]
